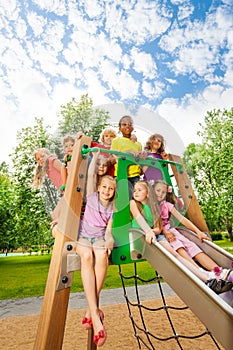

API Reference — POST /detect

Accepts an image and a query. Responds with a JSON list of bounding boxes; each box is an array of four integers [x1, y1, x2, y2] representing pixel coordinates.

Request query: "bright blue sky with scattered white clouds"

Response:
[[0, 0, 233, 163]]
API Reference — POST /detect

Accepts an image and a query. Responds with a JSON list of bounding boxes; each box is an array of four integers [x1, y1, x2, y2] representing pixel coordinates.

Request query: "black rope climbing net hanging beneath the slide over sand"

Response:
[[119, 263, 221, 350]]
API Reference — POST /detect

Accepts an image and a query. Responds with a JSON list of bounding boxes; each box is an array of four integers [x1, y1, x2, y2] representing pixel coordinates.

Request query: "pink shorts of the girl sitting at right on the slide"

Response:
[[168, 228, 202, 258]]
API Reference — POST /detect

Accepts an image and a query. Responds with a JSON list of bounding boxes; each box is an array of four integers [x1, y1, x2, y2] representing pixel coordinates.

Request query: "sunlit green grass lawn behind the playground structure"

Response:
[[0, 239, 233, 300]]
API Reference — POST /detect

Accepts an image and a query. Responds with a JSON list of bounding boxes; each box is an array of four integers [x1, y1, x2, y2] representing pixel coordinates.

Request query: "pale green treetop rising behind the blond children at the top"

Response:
[[59, 94, 110, 141]]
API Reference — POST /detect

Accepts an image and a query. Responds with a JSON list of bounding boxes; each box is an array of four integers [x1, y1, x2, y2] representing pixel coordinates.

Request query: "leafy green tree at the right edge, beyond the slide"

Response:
[[184, 108, 233, 241]]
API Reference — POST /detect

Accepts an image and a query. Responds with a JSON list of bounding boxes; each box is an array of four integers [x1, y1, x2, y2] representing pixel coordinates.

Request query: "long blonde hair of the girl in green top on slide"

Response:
[[134, 180, 163, 230]]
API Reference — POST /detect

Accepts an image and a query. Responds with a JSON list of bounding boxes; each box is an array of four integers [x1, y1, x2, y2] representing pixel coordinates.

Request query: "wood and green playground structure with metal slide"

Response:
[[34, 136, 233, 350]]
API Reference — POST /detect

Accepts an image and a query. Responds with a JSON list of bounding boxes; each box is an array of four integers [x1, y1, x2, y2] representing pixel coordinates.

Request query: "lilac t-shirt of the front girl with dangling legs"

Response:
[[80, 192, 113, 238]]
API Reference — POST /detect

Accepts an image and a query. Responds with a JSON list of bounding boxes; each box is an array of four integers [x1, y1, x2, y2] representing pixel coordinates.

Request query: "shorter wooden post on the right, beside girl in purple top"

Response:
[[169, 154, 209, 232]]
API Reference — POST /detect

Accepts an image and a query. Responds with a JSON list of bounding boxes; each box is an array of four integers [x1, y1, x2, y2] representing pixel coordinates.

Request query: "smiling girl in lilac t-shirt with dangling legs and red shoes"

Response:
[[76, 158, 116, 346]]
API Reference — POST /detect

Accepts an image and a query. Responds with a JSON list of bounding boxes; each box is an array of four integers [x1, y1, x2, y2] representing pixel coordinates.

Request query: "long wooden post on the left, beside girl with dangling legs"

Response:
[[34, 136, 91, 350]]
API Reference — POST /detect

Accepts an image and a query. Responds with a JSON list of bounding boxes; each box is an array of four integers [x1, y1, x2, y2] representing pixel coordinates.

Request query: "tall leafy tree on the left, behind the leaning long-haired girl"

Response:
[[11, 119, 54, 247]]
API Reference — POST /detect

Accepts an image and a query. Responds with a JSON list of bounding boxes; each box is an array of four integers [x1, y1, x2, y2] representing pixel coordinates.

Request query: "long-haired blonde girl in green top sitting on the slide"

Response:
[[130, 180, 233, 294]]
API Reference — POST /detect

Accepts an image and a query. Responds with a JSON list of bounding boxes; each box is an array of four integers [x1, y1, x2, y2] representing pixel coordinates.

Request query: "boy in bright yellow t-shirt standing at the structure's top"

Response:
[[111, 115, 142, 186]]
